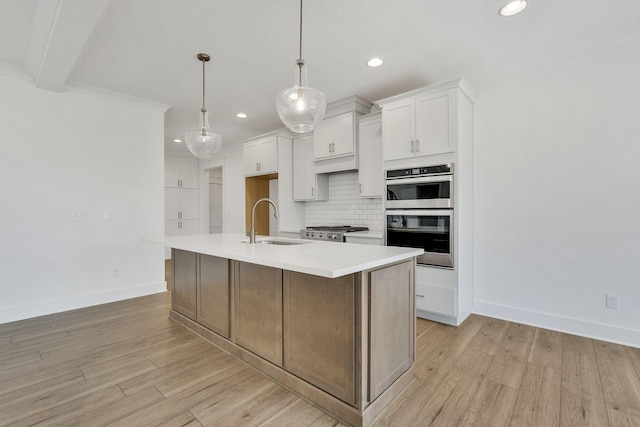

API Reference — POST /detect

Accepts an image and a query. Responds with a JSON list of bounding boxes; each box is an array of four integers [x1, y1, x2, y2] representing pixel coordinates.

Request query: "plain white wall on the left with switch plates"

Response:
[[0, 75, 165, 323]]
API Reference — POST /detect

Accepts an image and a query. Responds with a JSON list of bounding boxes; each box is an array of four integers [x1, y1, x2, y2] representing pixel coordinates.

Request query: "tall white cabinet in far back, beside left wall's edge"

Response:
[[164, 155, 198, 258]]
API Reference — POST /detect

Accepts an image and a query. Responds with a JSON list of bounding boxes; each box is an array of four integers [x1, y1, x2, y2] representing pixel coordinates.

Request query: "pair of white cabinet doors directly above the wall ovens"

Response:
[[382, 88, 456, 161]]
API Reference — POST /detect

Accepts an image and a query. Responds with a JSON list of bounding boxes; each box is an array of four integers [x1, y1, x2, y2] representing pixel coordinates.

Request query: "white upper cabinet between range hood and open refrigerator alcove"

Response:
[[293, 135, 329, 201]]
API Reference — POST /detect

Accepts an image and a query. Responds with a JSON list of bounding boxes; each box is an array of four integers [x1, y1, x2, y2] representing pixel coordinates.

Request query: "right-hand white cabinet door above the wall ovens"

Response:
[[416, 89, 456, 155]]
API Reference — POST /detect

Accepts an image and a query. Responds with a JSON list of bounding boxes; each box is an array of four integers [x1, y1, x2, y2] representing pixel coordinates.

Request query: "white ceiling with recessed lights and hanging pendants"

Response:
[[0, 0, 640, 155]]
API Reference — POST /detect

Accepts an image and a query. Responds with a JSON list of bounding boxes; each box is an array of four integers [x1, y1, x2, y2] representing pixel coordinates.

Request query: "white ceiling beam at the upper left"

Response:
[[27, 0, 111, 92]]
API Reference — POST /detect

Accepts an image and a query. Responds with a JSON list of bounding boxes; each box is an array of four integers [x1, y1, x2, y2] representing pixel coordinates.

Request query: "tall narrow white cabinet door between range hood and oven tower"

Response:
[[358, 116, 384, 197]]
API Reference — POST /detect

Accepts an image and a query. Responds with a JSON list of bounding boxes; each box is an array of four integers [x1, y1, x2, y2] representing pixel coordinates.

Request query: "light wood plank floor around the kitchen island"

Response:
[[0, 293, 640, 427]]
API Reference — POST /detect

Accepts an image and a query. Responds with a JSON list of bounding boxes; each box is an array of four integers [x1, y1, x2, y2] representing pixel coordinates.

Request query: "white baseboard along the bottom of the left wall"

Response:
[[0, 281, 167, 324]]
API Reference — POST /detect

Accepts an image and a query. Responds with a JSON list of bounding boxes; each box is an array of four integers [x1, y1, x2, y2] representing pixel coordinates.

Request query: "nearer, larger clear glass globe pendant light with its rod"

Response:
[[276, 0, 327, 133]]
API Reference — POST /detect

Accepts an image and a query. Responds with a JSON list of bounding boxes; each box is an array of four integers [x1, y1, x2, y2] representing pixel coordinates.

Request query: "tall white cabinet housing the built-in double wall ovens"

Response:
[[377, 79, 475, 325]]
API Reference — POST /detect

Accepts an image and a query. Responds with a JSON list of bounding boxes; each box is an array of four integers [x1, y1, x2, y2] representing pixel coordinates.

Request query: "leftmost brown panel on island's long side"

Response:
[[171, 249, 198, 320]]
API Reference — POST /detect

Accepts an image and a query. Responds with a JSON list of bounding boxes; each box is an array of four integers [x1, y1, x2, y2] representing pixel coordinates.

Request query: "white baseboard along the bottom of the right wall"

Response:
[[473, 301, 640, 348]]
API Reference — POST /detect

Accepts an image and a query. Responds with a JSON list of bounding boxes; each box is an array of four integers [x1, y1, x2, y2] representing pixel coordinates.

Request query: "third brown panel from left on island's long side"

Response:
[[235, 262, 282, 366]]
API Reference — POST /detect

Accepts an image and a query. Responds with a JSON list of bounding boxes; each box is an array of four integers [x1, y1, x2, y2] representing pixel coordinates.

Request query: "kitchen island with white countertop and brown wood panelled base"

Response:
[[165, 234, 422, 426]]
